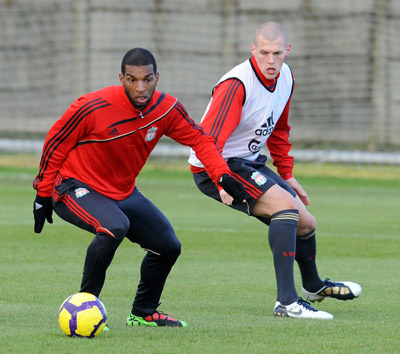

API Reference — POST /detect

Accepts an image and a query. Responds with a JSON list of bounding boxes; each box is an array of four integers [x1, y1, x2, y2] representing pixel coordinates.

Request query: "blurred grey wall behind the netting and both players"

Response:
[[0, 0, 400, 150]]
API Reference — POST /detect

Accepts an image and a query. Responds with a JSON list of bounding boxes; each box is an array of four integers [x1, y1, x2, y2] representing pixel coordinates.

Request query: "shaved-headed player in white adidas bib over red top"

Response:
[[189, 22, 361, 319]]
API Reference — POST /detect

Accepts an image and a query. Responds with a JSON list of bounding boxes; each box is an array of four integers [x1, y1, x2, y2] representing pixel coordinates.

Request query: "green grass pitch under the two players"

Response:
[[0, 156, 400, 353]]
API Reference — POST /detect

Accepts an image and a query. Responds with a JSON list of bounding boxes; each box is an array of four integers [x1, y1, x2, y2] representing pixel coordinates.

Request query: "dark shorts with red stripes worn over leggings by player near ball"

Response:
[[53, 178, 181, 256]]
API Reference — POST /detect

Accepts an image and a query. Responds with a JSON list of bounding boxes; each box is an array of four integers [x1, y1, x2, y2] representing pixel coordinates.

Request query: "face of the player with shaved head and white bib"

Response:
[[250, 36, 291, 80]]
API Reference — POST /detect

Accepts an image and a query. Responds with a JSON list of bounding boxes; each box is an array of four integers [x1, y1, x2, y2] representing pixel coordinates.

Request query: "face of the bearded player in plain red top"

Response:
[[119, 64, 158, 110]]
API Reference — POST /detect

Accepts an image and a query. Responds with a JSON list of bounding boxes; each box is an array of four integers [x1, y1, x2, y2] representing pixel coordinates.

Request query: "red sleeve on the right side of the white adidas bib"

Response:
[[267, 95, 293, 180]]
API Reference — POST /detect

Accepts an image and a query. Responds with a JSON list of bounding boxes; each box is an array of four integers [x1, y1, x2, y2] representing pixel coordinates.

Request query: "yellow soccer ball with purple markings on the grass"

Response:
[[58, 293, 107, 338]]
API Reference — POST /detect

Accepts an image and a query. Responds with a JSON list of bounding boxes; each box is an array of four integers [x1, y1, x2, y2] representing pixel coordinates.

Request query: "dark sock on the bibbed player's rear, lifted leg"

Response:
[[296, 230, 324, 292]]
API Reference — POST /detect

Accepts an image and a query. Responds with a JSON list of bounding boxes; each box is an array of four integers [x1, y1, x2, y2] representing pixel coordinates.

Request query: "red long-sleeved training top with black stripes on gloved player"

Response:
[[33, 85, 232, 200]]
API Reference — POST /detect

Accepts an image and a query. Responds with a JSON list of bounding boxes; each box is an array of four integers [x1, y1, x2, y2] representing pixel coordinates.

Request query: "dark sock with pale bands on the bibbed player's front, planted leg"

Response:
[[268, 209, 299, 305]]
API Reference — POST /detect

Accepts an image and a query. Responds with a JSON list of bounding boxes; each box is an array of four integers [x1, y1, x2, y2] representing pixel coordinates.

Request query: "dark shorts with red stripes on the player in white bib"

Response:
[[193, 155, 296, 224]]
